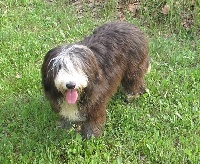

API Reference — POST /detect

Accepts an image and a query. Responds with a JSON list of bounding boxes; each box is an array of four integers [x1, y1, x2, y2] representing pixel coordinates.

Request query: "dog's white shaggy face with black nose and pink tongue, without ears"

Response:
[[47, 45, 93, 104]]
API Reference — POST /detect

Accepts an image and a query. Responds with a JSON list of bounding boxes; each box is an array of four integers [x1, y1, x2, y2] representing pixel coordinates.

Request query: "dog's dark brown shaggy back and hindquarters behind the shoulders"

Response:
[[80, 22, 149, 94]]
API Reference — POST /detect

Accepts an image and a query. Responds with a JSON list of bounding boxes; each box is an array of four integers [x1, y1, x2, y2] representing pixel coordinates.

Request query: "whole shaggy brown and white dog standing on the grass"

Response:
[[41, 22, 150, 139]]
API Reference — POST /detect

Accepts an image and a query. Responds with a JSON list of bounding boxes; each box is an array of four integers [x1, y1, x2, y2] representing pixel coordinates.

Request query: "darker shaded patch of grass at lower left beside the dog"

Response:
[[0, 95, 83, 159]]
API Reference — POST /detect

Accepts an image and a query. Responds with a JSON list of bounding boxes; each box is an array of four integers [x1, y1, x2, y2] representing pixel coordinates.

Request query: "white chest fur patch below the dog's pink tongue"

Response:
[[59, 101, 85, 121]]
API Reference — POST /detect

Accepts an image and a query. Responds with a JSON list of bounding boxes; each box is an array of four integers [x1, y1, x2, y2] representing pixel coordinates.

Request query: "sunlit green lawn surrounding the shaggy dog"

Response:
[[0, 0, 200, 164]]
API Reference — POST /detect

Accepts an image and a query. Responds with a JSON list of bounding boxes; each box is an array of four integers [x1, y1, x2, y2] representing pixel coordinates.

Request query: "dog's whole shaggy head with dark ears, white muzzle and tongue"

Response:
[[42, 45, 99, 104]]
